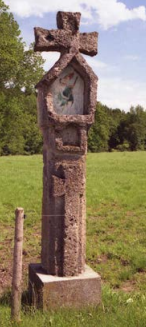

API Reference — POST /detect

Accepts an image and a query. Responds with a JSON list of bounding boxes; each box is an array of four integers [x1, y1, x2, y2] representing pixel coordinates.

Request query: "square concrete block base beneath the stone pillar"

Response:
[[29, 264, 101, 310]]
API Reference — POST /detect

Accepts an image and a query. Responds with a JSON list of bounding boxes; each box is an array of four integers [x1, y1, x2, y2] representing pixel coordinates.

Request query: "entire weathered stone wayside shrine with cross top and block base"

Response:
[[29, 12, 100, 307]]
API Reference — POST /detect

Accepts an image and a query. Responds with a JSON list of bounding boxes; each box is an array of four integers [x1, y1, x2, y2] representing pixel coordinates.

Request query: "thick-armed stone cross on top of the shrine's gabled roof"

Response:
[[34, 11, 98, 56]]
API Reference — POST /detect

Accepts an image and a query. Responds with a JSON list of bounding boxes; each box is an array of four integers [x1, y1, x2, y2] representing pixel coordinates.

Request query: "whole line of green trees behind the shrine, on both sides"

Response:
[[0, 0, 146, 155]]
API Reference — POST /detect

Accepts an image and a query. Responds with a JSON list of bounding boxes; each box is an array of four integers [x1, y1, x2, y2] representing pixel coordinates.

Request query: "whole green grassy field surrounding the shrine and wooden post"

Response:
[[0, 152, 146, 327]]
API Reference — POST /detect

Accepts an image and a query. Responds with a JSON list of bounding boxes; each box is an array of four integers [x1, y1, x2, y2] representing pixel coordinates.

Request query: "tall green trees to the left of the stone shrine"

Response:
[[0, 0, 44, 155]]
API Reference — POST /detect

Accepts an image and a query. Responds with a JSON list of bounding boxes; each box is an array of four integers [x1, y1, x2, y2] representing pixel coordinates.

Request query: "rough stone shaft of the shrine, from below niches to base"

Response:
[[42, 145, 86, 276]]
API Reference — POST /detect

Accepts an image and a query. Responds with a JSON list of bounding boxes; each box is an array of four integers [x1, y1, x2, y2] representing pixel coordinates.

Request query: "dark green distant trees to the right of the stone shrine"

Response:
[[88, 103, 146, 152]]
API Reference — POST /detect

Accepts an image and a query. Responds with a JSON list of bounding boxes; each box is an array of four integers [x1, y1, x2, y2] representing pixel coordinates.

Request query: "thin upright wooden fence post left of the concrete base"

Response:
[[11, 208, 24, 321]]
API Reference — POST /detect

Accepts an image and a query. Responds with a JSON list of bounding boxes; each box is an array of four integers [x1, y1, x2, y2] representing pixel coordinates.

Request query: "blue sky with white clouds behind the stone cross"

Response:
[[4, 0, 146, 112]]
